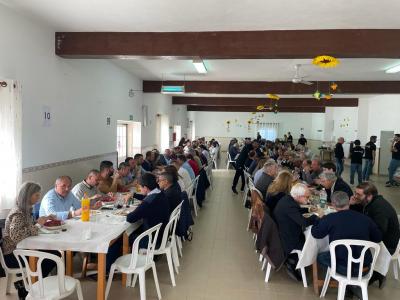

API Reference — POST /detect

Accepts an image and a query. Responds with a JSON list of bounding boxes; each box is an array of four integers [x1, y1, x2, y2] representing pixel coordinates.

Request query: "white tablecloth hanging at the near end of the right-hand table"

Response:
[[296, 226, 391, 276]]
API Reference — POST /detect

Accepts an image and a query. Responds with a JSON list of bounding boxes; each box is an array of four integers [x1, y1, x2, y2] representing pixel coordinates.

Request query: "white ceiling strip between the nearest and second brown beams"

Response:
[[113, 58, 400, 81]]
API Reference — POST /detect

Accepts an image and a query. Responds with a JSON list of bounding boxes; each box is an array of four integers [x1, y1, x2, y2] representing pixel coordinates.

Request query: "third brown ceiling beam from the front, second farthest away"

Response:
[[172, 96, 358, 108]]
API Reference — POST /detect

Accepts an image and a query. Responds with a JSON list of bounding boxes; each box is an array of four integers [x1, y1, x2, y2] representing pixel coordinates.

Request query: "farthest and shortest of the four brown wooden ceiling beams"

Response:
[[187, 105, 325, 113]]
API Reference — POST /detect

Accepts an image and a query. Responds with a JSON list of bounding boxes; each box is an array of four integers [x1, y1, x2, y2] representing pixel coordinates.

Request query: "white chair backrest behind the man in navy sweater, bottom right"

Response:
[[329, 240, 380, 281]]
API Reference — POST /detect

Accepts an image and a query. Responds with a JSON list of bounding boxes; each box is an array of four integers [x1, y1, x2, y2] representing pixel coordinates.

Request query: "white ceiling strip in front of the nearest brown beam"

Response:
[[0, 0, 400, 31]]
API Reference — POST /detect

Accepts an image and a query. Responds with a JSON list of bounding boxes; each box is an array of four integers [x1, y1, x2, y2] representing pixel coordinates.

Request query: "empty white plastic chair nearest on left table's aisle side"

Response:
[[106, 223, 162, 300]]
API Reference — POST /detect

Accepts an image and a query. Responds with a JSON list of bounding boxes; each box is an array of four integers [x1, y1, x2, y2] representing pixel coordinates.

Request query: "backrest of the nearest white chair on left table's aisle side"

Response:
[[129, 223, 162, 269]]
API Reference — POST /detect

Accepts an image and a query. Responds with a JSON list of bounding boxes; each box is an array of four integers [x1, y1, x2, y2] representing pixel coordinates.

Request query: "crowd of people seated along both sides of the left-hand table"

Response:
[[1, 138, 219, 299]]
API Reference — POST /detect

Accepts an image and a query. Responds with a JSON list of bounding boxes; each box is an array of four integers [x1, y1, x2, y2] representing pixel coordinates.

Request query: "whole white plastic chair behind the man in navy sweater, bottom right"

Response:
[[320, 240, 380, 300]]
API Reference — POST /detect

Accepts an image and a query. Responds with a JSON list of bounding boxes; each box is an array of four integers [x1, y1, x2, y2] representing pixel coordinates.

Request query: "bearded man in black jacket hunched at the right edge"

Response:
[[350, 182, 400, 287]]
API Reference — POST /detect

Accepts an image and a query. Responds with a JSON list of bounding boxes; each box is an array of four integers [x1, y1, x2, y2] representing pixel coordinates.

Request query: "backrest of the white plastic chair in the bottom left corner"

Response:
[[14, 249, 66, 299]]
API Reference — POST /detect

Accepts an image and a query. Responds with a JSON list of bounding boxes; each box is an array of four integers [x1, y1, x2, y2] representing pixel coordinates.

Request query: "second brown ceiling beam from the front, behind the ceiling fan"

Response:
[[143, 80, 400, 95]]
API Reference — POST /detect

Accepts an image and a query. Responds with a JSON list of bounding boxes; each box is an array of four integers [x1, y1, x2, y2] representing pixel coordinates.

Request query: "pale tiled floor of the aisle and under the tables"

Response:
[[0, 170, 400, 300]]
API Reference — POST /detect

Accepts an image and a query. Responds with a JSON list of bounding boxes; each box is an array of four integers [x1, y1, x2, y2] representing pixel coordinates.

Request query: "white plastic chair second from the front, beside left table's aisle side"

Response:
[[154, 215, 179, 286]]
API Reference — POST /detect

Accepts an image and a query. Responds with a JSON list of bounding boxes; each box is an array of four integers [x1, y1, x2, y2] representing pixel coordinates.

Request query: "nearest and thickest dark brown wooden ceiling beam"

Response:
[[55, 29, 400, 59]]
